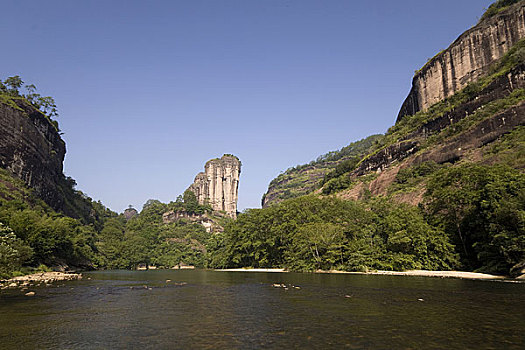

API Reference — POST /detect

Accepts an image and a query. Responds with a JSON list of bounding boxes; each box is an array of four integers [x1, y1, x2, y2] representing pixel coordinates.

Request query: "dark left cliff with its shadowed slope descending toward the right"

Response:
[[0, 89, 105, 225]]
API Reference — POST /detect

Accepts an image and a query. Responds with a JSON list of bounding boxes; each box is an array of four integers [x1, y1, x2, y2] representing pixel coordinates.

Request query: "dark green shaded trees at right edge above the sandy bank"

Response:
[[425, 164, 525, 273]]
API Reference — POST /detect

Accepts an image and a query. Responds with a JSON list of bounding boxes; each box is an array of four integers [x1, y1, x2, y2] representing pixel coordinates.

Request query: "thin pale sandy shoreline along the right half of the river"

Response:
[[215, 268, 508, 280]]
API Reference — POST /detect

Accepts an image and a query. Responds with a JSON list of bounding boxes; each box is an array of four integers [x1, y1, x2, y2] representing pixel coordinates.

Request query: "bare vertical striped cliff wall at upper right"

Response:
[[397, 1, 525, 121]]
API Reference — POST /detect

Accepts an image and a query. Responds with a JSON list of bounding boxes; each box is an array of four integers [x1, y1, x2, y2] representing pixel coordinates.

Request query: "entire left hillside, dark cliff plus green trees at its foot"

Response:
[[0, 76, 116, 278]]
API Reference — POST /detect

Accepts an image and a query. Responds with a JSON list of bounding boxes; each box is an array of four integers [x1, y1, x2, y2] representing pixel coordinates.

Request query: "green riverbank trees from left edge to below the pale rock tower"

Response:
[[0, 174, 219, 278]]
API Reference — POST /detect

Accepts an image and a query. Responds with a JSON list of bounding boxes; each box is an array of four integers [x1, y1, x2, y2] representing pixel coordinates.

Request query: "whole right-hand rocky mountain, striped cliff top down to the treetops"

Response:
[[263, 0, 525, 206]]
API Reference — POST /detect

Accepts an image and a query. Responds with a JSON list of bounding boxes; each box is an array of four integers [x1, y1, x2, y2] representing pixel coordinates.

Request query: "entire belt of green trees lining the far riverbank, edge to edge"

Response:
[[0, 164, 525, 278]]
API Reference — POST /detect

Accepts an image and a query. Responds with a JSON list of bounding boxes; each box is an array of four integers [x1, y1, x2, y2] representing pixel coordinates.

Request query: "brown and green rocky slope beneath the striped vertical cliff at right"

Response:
[[332, 40, 525, 204]]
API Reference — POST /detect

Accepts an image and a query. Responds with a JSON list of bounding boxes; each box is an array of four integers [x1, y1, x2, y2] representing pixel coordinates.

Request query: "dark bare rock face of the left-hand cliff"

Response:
[[0, 100, 66, 210]]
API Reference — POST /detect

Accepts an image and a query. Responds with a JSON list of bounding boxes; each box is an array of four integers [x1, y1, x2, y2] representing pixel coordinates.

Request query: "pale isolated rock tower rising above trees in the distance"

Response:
[[189, 155, 241, 218]]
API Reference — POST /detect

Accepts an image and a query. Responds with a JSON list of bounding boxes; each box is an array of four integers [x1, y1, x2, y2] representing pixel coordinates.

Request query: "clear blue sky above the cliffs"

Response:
[[0, 0, 492, 212]]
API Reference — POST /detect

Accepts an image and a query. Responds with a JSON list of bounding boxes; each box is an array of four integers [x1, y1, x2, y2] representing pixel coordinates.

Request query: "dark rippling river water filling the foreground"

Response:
[[0, 270, 525, 349]]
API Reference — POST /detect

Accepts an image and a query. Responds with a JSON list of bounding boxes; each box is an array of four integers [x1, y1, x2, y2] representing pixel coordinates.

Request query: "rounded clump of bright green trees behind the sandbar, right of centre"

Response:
[[210, 195, 458, 271]]
